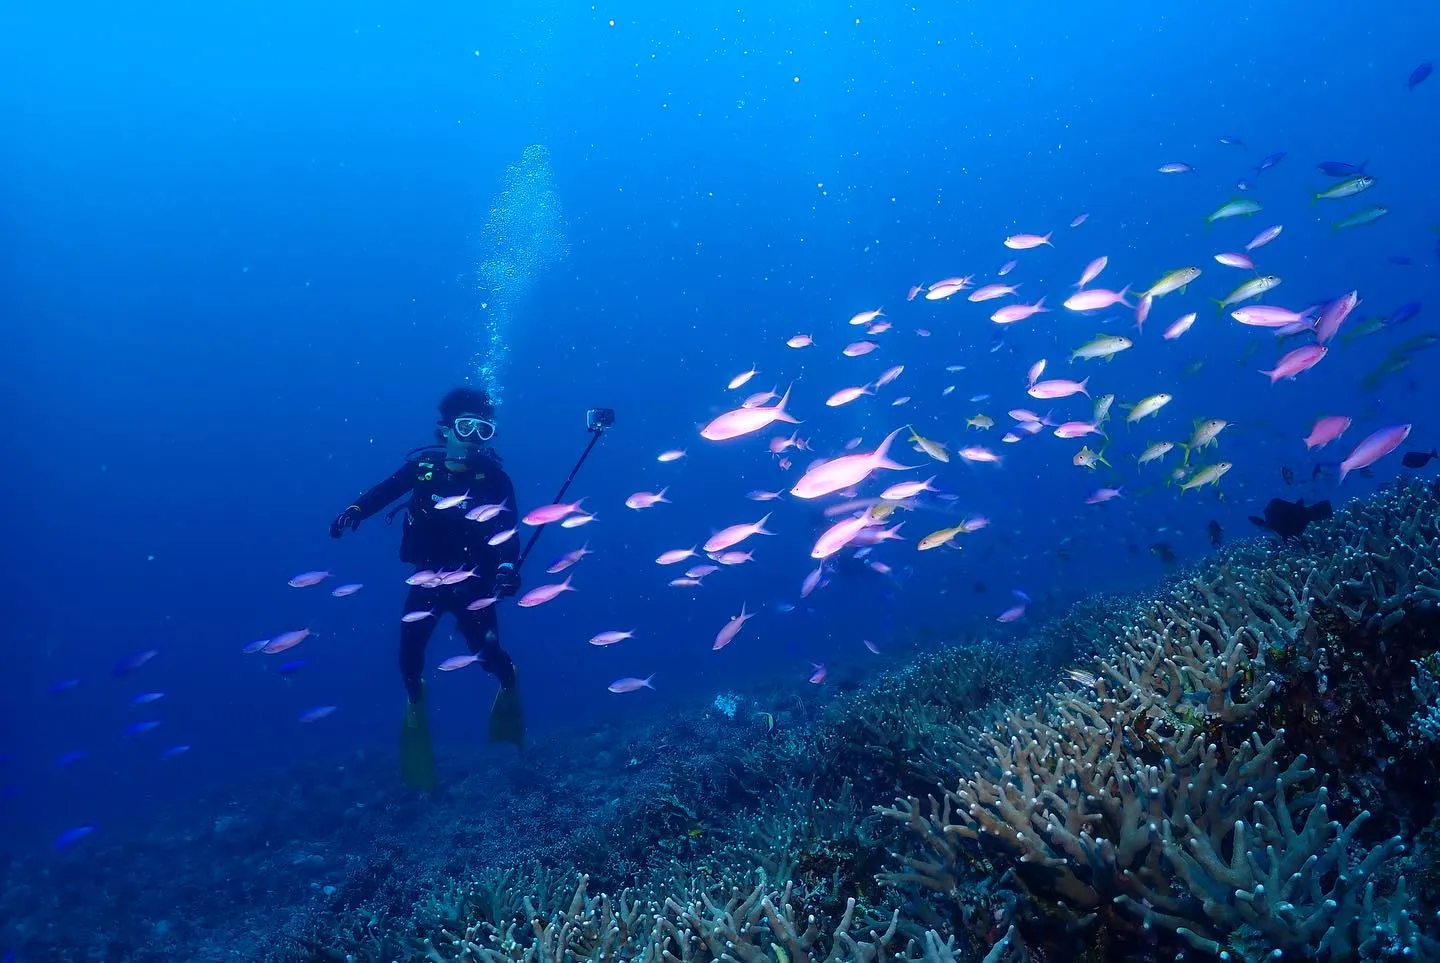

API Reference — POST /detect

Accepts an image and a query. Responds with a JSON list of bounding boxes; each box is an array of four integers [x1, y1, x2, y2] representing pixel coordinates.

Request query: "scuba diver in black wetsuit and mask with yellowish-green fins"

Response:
[[330, 387, 524, 790]]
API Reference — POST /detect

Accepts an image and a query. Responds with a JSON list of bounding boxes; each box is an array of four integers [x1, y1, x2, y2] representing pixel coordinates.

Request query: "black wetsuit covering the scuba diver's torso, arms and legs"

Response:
[[345, 449, 520, 702]]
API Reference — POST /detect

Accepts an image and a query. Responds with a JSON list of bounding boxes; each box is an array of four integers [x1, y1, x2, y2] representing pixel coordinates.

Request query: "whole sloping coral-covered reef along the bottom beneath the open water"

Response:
[[0, 485, 1440, 963]]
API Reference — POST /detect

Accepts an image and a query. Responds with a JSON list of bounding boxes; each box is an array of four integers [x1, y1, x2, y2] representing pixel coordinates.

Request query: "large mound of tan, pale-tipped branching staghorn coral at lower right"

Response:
[[881, 485, 1440, 959]]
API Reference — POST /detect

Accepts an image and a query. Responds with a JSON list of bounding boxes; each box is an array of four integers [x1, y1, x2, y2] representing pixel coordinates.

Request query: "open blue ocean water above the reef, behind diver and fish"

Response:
[[0, 1, 1440, 944]]
